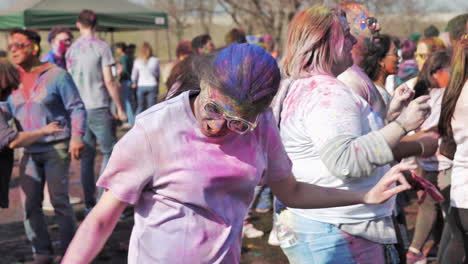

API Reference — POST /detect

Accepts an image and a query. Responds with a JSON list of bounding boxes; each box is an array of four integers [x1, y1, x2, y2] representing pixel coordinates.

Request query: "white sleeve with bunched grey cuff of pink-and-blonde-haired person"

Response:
[[303, 87, 393, 178]]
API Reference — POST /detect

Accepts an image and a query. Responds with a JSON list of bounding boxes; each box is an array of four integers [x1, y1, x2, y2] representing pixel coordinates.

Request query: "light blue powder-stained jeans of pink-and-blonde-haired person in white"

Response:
[[277, 210, 385, 264]]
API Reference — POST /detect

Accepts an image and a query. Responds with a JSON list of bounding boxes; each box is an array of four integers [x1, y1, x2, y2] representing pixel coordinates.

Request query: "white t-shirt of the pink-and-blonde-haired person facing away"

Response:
[[280, 73, 394, 224]]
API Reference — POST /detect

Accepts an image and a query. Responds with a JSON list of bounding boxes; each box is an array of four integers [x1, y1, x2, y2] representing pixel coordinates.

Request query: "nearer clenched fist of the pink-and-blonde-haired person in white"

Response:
[[396, 95, 431, 131]]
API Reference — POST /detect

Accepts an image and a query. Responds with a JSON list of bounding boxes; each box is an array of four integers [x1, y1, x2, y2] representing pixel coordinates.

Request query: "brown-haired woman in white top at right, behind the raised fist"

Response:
[[406, 51, 452, 263]]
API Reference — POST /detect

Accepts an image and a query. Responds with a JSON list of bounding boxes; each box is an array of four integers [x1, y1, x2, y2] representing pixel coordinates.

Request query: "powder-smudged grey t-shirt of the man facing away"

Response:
[[66, 36, 115, 109]]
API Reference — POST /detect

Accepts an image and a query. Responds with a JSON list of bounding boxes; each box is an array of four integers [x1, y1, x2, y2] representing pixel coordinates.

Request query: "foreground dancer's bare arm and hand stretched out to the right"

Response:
[[269, 164, 416, 209]]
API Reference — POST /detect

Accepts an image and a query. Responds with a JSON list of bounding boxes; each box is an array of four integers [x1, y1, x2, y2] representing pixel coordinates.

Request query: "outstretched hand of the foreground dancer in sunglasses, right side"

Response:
[[363, 163, 416, 204]]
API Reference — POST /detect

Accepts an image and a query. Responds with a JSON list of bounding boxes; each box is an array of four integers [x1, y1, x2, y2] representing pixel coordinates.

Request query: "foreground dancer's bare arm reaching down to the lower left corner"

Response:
[[62, 191, 127, 264]]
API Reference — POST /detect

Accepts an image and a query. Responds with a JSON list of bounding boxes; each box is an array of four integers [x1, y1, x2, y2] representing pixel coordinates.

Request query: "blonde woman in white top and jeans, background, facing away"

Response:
[[132, 42, 160, 114]]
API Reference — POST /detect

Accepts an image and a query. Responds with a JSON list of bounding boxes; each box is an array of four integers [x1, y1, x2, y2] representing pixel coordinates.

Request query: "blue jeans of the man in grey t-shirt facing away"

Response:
[[81, 108, 117, 208]]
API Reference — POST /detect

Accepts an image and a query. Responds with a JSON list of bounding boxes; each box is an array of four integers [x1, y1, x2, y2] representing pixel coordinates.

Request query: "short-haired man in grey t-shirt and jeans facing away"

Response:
[[66, 9, 127, 212]]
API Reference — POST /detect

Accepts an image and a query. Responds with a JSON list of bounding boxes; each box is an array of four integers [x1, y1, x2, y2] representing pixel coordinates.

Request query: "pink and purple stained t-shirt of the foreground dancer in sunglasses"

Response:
[[97, 91, 291, 264]]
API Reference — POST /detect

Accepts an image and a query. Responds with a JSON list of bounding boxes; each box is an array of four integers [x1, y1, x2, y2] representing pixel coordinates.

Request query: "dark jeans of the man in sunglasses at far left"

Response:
[[20, 149, 76, 255]]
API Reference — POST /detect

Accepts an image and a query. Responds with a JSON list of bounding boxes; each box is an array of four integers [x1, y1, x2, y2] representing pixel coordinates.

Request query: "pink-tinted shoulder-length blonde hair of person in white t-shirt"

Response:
[[283, 5, 345, 78]]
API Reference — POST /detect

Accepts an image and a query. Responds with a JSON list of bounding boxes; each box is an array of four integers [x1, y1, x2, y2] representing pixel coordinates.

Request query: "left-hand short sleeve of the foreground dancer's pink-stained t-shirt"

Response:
[[97, 122, 155, 205]]
